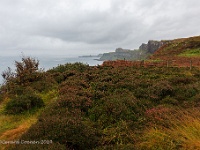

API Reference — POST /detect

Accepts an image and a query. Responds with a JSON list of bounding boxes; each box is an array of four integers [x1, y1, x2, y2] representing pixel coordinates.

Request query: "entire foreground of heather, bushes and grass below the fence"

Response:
[[0, 35, 200, 150]]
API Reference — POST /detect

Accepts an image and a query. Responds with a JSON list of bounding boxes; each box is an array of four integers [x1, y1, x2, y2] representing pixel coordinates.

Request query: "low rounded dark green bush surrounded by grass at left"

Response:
[[6, 93, 44, 114]]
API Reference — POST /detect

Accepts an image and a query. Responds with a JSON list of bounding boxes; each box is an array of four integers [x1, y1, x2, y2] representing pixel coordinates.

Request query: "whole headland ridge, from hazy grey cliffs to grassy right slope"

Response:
[[99, 36, 200, 61]]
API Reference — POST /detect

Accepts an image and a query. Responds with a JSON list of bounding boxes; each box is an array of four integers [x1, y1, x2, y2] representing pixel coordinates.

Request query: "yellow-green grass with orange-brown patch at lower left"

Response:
[[0, 89, 58, 150]]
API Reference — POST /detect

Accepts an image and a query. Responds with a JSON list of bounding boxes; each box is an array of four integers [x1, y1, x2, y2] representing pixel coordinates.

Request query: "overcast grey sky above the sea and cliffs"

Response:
[[0, 0, 200, 56]]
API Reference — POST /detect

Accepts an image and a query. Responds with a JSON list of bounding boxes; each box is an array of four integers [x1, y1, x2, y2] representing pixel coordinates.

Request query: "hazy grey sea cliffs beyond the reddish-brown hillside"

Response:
[[100, 40, 165, 61]]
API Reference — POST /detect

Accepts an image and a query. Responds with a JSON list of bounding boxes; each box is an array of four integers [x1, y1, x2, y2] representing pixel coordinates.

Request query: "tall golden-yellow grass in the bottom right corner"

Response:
[[138, 108, 200, 150]]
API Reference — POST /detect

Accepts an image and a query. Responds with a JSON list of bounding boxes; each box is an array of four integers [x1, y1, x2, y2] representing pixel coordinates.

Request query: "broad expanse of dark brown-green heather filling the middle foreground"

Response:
[[5, 63, 200, 150]]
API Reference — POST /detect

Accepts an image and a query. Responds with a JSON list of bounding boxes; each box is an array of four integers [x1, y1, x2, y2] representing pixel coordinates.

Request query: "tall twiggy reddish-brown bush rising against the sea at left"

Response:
[[2, 57, 56, 97]]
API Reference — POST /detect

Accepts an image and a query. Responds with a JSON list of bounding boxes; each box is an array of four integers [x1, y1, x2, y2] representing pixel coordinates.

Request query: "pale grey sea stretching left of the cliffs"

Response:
[[0, 55, 103, 84]]
